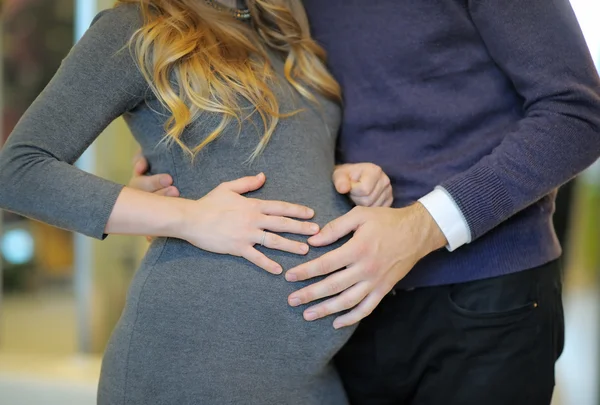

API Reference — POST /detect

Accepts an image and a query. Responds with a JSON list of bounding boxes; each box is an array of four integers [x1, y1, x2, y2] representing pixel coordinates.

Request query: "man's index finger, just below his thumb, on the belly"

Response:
[[285, 242, 354, 280]]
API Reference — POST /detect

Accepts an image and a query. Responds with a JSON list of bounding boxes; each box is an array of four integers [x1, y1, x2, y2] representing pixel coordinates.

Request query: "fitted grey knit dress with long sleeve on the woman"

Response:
[[0, 6, 353, 405]]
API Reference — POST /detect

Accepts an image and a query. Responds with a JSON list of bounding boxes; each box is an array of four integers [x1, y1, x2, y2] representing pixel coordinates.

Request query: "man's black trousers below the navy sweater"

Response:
[[335, 262, 564, 405]]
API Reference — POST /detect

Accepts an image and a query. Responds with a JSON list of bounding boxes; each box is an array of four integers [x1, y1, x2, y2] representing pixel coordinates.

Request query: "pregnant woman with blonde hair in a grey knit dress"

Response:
[[0, 0, 390, 405]]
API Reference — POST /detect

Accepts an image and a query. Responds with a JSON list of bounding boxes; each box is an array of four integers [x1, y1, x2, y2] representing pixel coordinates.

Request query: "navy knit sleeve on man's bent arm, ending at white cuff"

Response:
[[441, 0, 600, 240]]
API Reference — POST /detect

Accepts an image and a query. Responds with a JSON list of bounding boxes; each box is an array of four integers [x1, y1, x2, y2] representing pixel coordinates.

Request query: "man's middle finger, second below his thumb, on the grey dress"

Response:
[[286, 267, 366, 306]]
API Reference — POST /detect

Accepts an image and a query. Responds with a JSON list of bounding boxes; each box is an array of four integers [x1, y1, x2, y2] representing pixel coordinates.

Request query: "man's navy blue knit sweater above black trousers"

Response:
[[304, 0, 600, 287]]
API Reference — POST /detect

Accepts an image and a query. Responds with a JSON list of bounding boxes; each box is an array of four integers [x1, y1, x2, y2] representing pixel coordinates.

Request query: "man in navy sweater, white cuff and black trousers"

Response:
[[130, 0, 600, 405]]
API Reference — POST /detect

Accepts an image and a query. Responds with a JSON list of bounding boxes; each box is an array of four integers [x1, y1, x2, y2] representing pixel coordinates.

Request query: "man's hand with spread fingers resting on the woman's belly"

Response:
[[285, 203, 446, 328]]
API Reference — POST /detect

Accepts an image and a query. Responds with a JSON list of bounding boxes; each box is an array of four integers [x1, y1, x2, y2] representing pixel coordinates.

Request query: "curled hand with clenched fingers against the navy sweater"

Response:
[[333, 163, 394, 207]]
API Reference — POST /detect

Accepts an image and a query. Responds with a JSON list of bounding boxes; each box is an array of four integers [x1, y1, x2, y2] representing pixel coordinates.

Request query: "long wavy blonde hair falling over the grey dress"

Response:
[[116, 0, 341, 159]]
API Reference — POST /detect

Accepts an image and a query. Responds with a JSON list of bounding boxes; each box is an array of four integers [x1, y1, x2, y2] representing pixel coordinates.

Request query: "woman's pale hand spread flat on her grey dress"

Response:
[[179, 173, 319, 274]]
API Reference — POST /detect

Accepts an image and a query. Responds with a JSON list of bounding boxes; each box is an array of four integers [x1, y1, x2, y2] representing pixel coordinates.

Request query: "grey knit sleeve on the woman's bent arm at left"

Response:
[[0, 6, 147, 239]]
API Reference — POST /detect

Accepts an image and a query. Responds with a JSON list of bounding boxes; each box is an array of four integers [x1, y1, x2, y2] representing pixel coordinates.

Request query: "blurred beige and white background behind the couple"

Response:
[[0, 0, 600, 405]]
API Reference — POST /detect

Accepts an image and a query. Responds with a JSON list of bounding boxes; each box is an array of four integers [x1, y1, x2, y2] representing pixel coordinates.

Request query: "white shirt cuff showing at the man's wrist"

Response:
[[419, 186, 471, 252]]
